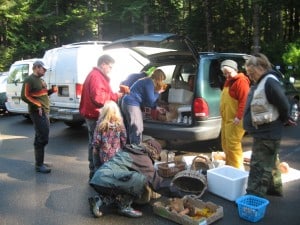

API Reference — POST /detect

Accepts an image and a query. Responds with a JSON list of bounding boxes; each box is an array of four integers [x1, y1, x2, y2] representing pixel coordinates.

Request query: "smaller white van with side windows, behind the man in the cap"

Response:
[[5, 58, 40, 116]]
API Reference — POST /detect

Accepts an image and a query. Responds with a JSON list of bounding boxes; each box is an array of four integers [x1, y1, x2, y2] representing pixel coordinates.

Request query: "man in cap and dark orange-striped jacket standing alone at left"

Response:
[[21, 60, 57, 173]]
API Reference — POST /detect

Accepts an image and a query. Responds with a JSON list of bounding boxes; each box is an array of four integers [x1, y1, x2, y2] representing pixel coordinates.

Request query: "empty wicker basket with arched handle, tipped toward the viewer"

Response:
[[171, 157, 207, 198]]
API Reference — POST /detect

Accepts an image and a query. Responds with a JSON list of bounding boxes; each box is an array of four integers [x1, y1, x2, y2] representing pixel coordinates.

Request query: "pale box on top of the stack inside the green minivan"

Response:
[[168, 88, 194, 104]]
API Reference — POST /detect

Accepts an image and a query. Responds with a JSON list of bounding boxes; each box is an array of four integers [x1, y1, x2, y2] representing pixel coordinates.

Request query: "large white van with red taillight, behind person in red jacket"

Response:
[[43, 41, 143, 127]]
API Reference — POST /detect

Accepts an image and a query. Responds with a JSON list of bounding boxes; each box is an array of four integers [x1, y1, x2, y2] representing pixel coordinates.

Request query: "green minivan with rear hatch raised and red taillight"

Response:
[[103, 33, 299, 146]]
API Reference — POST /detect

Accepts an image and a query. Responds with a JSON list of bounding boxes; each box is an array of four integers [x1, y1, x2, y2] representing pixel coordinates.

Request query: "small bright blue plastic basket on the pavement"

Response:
[[236, 195, 269, 222]]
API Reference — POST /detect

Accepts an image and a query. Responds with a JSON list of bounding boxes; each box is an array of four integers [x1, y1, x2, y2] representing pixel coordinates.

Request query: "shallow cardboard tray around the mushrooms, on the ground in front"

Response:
[[153, 196, 224, 225]]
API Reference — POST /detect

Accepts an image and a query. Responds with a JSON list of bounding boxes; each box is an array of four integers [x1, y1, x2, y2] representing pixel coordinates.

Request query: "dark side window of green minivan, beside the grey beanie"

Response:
[[209, 59, 225, 89]]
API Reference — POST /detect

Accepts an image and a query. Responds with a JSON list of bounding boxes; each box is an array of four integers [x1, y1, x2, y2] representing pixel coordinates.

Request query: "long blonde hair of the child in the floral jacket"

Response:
[[96, 101, 123, 132]]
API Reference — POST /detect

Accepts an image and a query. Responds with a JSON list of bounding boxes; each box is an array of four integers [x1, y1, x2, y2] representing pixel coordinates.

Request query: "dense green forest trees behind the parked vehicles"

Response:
[[0, 0, 300, 79]]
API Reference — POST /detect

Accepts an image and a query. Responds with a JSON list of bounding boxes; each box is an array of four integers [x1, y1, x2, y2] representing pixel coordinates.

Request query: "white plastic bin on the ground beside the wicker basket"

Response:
[[207, 165, 249, 201]]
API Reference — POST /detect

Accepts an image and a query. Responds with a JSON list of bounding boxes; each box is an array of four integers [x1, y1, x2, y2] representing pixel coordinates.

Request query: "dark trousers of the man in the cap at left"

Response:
[[30, 111, 50, 166]]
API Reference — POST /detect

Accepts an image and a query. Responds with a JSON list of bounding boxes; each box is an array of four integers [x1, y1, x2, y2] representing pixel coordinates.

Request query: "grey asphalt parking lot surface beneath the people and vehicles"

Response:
[[0, 116, 300, 225]]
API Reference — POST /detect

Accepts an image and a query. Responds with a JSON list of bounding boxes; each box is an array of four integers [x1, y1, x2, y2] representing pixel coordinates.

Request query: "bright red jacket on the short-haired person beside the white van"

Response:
[[79, 67, 118, 120]]
